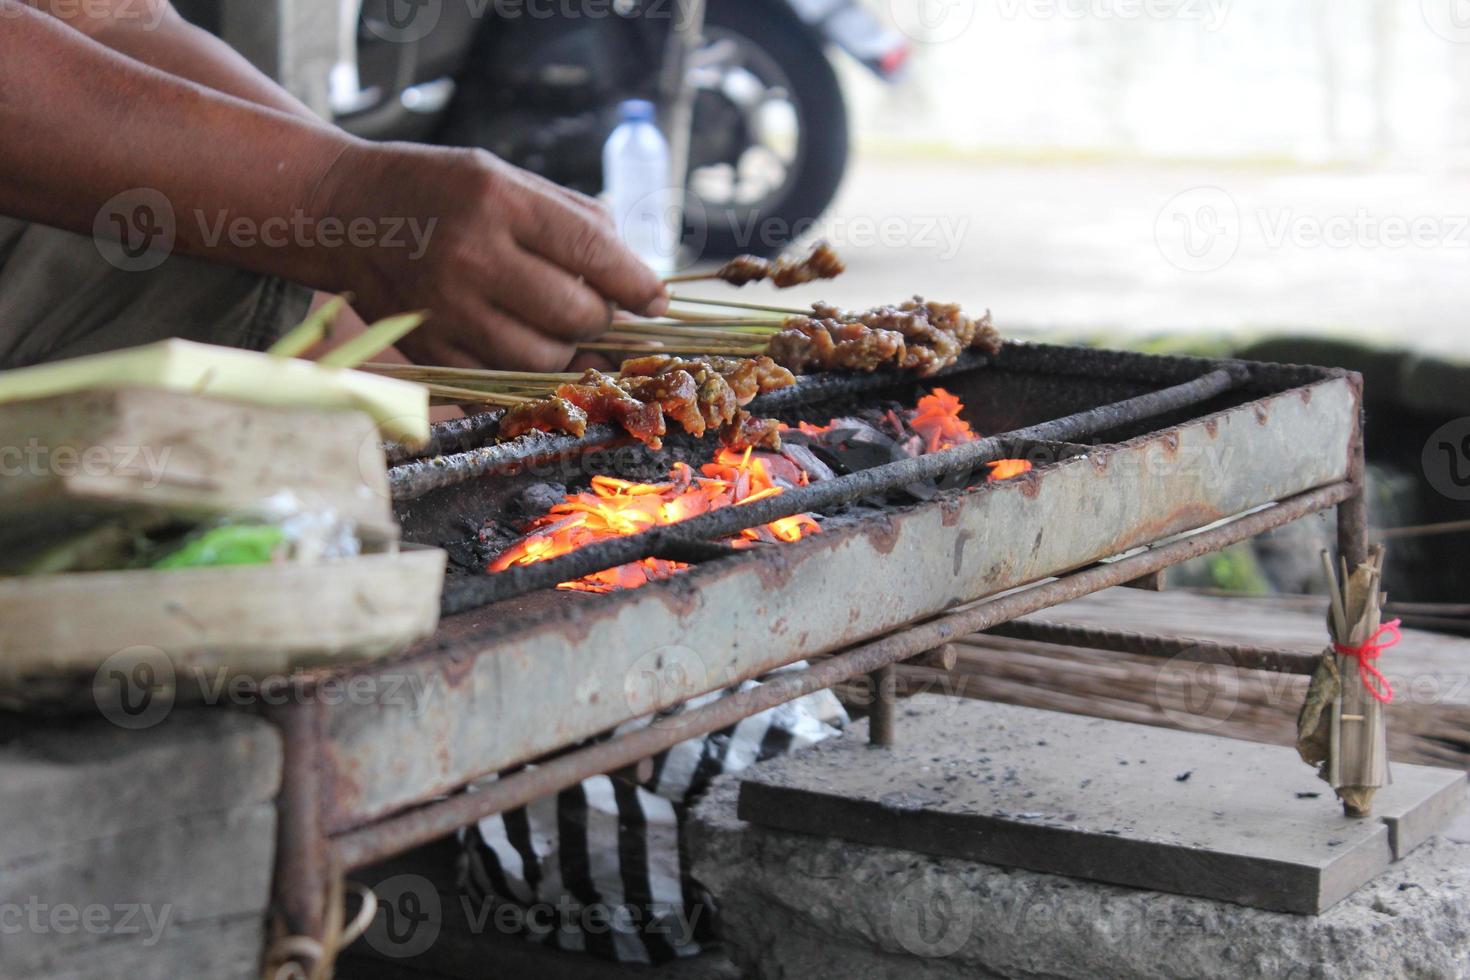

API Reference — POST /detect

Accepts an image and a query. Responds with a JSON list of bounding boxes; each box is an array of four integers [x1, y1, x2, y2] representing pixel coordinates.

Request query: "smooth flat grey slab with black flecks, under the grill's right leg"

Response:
[[739, 696, 1466, 914]]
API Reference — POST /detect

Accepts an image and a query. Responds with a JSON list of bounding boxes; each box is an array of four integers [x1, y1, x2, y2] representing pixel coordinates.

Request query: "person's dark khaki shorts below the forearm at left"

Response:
[[0, 217, 312, 367]]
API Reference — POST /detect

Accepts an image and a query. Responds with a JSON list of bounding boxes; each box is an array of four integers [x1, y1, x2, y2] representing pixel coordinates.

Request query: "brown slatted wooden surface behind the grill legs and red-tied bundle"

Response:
[[854, 589, 1470, 768]]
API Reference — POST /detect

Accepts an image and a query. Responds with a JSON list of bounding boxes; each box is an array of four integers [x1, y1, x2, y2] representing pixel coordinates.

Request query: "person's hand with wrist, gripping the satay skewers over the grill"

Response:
[[321, 144, 667, 372]]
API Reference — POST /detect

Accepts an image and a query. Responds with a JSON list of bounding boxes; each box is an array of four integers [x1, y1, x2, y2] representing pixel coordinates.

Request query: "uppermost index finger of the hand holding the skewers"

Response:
[[517, 189, 669, 316]]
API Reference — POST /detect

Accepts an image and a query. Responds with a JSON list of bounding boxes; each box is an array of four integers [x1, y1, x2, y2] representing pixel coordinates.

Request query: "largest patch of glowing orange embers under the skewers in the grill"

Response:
[[490, 450, 822, 592]]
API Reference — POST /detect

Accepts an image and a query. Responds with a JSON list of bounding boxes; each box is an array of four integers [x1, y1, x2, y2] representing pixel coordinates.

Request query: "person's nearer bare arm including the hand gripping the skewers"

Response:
[[0, 0, 666, 370]]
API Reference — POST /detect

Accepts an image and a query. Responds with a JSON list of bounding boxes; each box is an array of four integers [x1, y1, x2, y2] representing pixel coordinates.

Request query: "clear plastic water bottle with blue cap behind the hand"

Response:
[[603, 98, 678, 276]]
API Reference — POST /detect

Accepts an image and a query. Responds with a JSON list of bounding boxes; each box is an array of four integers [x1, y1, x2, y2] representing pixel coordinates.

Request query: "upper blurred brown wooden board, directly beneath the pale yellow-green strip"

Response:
[[0, 388, 397, 542]]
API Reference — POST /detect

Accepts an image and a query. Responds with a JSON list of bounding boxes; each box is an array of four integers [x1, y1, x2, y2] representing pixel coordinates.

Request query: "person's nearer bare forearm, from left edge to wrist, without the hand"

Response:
[[0, 0, 356, 289]]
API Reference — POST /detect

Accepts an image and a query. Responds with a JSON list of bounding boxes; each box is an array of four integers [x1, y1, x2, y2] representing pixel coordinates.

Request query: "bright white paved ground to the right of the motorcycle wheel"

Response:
[[705, 157, 1470, 357]]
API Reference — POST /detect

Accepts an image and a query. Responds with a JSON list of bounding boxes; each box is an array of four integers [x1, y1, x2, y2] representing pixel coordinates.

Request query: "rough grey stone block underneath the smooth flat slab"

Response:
[[689, 769, 1470, 980]]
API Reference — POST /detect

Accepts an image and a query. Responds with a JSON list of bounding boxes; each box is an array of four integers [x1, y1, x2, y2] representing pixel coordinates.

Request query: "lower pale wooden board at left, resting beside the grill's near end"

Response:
[[0, 548, 445, 704]]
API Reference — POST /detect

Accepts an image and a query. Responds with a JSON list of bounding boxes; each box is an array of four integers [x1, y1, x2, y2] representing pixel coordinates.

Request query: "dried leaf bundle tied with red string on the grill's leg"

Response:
[[1297, 547, 1399, 817]]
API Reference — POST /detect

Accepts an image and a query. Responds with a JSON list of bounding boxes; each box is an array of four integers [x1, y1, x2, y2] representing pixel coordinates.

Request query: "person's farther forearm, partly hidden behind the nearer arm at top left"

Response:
[[25, 0, 316, 119]]
